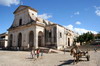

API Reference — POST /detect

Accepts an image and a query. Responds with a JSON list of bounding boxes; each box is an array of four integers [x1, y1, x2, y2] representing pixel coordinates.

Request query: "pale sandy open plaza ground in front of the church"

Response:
[[0, 50, 100, 66]]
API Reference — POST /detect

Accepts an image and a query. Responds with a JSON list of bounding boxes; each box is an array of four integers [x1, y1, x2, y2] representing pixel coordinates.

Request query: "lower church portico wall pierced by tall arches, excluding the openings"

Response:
[[9, 26, 45, 49]]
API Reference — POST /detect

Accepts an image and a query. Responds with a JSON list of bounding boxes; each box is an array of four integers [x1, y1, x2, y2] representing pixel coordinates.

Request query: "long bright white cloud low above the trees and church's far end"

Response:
[[65, 24, 97, 35]]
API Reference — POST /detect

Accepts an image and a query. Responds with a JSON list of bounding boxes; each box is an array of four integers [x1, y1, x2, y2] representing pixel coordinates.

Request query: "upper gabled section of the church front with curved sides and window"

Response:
[[12, 5, 37, 27]]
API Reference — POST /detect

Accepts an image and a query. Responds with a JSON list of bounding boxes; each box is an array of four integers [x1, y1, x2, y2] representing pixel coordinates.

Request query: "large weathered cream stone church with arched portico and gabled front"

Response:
[[8, 5, 77, 50]]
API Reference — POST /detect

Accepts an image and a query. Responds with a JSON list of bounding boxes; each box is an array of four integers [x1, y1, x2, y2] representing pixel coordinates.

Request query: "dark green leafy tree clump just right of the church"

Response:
[[77, 32, 94, 45]]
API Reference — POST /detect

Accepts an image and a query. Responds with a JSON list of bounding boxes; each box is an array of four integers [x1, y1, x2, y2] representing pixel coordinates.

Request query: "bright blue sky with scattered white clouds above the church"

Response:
[[0, 0, 100, 34]]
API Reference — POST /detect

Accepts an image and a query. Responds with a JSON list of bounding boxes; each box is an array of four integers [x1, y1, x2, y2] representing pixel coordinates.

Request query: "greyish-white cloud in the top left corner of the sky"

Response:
[[0, 0, 20, 6]]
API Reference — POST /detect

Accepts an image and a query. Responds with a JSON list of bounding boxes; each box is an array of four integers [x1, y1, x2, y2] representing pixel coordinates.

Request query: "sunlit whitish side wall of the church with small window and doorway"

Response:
[[57, 25, 74, 49]]
